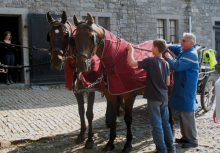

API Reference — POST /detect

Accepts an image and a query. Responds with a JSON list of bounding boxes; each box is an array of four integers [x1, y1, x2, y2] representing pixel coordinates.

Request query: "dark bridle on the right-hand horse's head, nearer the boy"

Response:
[[73, 22, 105, 60]]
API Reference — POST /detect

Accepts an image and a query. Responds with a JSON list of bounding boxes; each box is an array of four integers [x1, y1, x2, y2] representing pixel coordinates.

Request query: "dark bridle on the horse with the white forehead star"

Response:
[[47, 21, 72, 57]]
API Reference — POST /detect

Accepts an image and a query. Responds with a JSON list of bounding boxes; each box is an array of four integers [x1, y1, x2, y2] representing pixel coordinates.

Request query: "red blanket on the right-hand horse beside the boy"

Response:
[[99, 30, 154, 95]]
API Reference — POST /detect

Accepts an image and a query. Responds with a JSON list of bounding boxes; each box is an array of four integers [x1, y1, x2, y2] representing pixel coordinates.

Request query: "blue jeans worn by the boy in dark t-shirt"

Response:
[[148, 99, 175, 153]]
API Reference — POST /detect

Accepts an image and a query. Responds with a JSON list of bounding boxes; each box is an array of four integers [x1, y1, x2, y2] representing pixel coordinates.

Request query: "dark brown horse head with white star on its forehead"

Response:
[[46, 11, 72, 70]]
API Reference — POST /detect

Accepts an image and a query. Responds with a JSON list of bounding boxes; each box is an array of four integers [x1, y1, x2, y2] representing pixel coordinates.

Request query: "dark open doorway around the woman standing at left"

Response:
[[0, 16, 23, 84]]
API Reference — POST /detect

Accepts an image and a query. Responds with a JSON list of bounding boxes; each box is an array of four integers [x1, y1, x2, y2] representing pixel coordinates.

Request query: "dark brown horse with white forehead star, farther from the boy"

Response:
[[46, 11, 98, 149]]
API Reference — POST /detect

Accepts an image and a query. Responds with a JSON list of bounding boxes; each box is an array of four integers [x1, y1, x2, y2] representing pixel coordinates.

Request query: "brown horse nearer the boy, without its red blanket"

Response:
[[73, 13, 151, 152]]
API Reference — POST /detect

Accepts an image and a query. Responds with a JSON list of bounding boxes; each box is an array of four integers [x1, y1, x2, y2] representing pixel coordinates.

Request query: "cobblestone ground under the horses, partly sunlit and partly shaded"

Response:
[[0, 86, 220, 153]]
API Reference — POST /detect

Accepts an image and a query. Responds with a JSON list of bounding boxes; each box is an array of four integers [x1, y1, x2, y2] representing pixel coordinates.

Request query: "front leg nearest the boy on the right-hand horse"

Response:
[[122, 92, 135, 153]]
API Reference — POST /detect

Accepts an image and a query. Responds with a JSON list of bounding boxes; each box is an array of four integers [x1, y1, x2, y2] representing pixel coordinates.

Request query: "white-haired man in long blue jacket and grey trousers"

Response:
[[165, 33, 199, 148]]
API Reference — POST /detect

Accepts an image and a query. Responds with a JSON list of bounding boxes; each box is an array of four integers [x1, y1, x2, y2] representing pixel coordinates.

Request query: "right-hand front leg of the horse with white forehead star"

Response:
[[85, 92, 95, 149]]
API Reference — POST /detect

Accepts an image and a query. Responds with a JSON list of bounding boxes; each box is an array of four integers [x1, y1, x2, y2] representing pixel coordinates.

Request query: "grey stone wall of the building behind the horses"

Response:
[[0, 0, 220, 85]]
